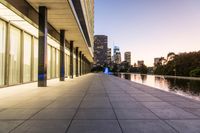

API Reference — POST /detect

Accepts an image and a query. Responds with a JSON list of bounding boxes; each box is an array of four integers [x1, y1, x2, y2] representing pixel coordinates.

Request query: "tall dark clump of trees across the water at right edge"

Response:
[[154, 51, 200, 77]]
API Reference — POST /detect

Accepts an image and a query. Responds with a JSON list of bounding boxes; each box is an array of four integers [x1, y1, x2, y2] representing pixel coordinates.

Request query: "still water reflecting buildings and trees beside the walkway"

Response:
[[115, 73, 200, 101]]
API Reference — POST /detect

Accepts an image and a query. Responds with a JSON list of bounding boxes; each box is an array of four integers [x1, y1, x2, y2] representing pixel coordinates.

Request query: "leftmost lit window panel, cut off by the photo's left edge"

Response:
[[0, 20, 6, 86]]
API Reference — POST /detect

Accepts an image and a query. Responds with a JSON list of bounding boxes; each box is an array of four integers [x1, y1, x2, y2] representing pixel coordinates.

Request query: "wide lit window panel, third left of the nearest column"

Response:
[[9, 26, 21, 85]]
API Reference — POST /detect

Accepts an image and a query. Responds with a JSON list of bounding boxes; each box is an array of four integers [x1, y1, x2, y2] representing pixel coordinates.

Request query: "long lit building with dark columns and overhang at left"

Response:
[[0, 0, 94, 87]]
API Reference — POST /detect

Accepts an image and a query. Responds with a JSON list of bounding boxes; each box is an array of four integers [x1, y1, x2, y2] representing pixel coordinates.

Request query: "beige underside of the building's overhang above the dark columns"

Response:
[[0, 0, 93, 62]]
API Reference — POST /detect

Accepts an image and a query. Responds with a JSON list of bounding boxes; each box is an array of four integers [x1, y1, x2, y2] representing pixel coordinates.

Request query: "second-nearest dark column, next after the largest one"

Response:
[[60, 30, 65, 81]]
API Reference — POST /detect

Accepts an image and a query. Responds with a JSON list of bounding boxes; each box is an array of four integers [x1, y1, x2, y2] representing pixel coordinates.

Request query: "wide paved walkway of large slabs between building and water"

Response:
[[0, 74, 200, 133]]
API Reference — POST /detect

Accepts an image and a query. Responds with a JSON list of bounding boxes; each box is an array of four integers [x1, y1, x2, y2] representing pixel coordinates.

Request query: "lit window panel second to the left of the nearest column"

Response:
[[23, 33, 32, 82]]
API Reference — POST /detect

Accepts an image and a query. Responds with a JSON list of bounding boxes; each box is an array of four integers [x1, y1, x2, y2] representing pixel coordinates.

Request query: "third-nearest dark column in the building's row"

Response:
[[70, 41, 74, 78]]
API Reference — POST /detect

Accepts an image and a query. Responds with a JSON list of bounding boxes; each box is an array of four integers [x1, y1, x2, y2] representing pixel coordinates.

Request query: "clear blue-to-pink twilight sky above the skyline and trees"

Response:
[[95, 0, 200, 66]]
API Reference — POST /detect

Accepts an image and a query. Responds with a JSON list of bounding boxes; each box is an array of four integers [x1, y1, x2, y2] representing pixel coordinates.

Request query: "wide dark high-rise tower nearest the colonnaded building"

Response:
[[94, 35, 108, 66]]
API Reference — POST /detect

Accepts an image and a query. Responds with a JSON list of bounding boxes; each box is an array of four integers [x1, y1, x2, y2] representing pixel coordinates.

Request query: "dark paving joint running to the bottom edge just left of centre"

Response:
[[65, 76, 93, 133]]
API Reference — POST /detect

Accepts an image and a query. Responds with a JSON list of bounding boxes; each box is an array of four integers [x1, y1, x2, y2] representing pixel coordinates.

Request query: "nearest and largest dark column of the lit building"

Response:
[[38, 6, 48, 87]]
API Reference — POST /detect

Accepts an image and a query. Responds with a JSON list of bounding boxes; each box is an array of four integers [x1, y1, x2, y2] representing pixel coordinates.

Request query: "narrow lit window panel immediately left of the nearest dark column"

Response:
[[33, 38, 38, 81]]
